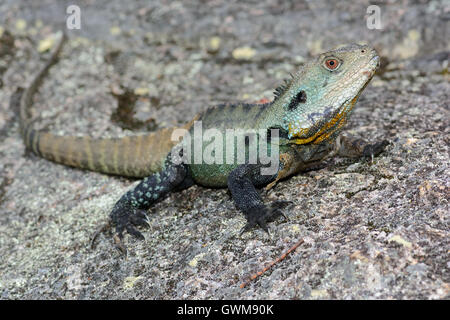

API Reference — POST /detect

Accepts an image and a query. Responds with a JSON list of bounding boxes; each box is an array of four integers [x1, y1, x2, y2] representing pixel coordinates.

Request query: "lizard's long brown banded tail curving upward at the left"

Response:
[[20, 34, 190, 177]]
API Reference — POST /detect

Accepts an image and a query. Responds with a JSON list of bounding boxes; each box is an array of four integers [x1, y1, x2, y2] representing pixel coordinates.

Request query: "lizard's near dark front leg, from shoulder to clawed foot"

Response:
[[228, 164, 288, 233]]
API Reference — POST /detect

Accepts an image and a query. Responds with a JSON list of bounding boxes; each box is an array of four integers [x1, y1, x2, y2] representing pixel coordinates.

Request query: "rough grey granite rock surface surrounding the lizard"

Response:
[[0, 0, 450, 299]]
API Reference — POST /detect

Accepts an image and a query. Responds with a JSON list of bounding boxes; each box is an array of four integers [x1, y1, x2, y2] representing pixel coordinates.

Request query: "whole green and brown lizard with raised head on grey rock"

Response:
[[19, 34, 389, 243]]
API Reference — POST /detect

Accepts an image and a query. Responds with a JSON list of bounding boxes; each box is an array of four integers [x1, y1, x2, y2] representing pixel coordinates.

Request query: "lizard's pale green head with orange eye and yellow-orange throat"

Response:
[[276, 44, 379, 144]]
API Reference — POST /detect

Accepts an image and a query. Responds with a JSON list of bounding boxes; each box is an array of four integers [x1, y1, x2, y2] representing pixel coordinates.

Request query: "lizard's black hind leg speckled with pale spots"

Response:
[[110, 156, 193, 239]]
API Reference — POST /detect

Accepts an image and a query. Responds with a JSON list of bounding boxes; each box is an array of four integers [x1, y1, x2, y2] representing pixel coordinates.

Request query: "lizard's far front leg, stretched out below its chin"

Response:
[[335, 135, 389, 158]]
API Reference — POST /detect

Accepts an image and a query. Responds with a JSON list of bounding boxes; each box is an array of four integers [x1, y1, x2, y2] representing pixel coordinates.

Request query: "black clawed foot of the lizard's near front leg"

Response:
[[240, 200, 292, 235]]
